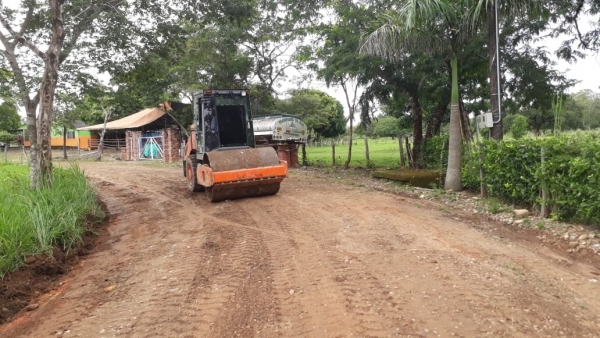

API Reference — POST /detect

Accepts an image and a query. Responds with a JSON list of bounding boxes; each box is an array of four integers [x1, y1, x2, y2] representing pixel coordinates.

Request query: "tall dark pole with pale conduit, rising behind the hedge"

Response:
[[487, 0, 503, 140]]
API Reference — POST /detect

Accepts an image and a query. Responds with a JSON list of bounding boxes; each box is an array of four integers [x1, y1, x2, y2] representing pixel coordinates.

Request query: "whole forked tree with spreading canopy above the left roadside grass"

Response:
[[0, 0, 192, 188]]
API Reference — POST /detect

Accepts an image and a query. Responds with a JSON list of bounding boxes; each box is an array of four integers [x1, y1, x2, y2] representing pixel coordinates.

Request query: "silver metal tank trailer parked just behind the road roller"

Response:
[[253, 114, 308, 167]]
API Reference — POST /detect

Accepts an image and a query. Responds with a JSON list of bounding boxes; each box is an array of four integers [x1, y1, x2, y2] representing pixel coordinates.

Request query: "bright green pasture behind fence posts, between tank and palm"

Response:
[[306, 137, 400, 168]]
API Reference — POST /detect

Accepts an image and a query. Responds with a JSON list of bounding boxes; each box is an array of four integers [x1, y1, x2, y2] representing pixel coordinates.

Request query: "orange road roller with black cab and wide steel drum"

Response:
[[183, 89, 287, 202]]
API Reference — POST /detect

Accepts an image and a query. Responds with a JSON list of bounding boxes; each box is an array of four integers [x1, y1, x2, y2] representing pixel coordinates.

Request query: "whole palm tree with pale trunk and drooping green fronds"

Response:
[[361, 0, 483, 191]]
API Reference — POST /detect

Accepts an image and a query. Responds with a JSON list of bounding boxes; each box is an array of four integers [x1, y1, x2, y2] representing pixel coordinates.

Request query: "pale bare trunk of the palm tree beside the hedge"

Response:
[[444, 55, 462, 191]]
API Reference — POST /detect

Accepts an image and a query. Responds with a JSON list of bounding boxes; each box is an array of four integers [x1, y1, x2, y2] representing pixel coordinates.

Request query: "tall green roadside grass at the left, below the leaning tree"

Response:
[[0, 163, 104, 278]]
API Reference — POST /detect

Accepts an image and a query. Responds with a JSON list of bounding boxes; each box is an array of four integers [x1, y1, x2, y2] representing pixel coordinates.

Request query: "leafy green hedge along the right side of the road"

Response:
[[424, 132, 600, 225]]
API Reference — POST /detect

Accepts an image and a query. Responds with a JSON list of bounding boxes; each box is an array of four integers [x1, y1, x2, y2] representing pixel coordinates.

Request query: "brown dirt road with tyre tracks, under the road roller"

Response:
[[0, 163, 600, 337]]
